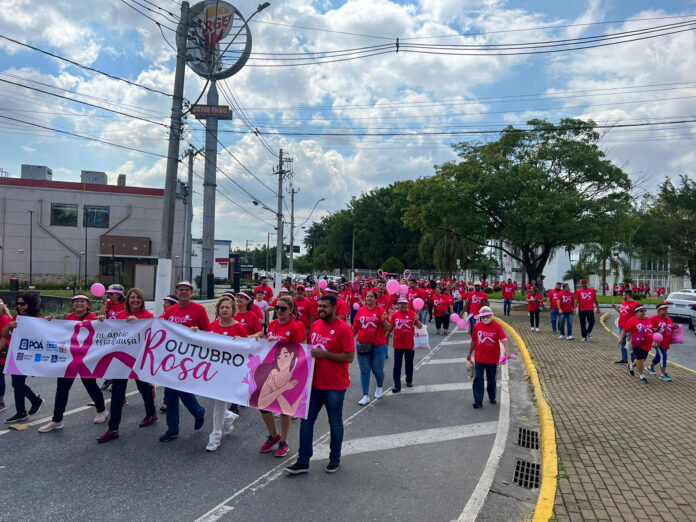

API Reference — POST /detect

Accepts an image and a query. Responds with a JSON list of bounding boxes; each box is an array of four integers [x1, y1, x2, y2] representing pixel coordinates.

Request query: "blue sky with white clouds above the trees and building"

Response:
[[0, 0, 696, 252]]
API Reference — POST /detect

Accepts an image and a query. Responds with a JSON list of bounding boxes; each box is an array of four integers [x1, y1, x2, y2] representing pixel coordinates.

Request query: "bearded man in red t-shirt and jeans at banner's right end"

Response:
[[285, 294, 355, 475]]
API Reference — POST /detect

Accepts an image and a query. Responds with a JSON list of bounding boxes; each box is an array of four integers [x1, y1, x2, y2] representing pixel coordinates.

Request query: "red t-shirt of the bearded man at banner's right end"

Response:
[[309, 320, 355, 390]]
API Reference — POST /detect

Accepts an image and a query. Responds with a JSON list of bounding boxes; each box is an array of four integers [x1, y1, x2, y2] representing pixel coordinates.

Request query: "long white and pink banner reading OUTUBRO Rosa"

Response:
[[5, 317, 314, 418]]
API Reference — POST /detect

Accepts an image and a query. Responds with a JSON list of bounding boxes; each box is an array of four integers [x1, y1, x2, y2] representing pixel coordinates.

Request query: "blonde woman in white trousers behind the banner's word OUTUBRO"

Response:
[[205, 296, 247, 451]]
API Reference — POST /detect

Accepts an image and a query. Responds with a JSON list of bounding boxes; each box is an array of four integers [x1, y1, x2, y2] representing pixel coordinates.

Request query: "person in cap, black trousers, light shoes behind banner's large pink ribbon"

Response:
[[39, 294, 108, 433]]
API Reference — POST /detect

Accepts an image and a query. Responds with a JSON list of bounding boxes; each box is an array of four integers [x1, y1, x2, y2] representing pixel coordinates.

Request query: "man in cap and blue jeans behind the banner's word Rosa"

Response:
[[160, 281, 210, 442]]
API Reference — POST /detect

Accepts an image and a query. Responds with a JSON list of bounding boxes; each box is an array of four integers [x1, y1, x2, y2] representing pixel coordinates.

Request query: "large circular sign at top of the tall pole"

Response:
[[186, 0, 251, 80]]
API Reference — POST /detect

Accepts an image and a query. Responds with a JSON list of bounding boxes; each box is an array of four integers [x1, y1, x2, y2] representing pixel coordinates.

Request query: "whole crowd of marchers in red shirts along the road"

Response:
[[0, 276, 673, 474]]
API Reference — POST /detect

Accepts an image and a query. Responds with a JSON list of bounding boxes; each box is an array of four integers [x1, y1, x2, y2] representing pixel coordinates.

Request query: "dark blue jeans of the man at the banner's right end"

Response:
[[297, 388, 346, 465]]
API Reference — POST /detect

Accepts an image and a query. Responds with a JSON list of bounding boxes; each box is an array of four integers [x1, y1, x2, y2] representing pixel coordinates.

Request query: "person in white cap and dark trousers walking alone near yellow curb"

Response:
[[466, 306, 510, 409]]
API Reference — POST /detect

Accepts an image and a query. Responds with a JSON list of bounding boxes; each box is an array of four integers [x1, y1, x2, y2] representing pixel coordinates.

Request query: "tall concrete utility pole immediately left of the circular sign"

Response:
[[156, 1, 189, 315]]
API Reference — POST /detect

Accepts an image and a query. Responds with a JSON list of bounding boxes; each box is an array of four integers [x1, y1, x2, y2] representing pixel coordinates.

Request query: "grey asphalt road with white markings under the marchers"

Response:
[[0, 316, 521, 521]]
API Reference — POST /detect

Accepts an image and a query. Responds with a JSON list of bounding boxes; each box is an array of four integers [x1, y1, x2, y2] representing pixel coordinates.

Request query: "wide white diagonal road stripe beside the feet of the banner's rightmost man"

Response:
[[312, 421, 498, 459]]
